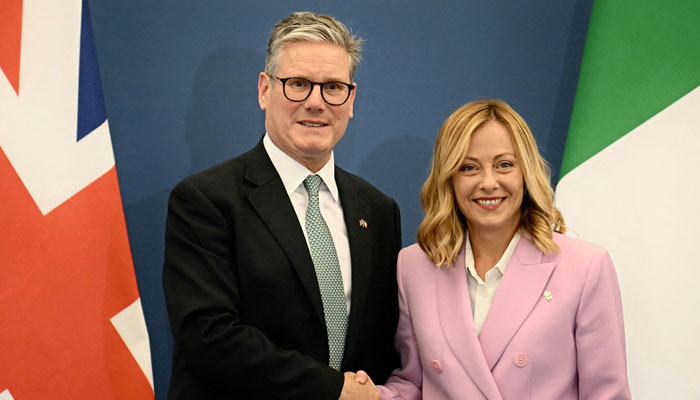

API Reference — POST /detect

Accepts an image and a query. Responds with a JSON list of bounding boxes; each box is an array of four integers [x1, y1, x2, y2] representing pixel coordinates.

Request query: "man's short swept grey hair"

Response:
[[265, 11, 363, 83]]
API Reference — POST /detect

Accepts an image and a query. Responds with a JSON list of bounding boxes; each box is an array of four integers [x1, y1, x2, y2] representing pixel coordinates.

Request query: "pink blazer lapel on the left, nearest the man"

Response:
[[435, 247, 501, 399]]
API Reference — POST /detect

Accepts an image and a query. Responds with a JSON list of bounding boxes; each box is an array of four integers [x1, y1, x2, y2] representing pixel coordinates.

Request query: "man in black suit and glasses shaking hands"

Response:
[[163, 12, 401, 399]]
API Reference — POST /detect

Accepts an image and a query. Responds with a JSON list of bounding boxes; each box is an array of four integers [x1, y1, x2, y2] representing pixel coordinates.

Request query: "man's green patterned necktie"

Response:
[[304, 175, 348, 371]]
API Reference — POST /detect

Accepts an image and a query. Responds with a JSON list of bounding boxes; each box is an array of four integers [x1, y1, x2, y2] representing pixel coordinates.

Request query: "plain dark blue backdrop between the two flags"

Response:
[[90, 0, 592, 399]]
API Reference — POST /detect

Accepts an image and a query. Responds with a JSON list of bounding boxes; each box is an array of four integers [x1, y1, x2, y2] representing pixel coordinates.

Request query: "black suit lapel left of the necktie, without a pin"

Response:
[[245, 141, 325, 328]]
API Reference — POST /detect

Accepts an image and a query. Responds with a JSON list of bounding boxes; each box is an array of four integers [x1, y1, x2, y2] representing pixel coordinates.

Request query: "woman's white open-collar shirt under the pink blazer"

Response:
[[464, 232, 520, 335]]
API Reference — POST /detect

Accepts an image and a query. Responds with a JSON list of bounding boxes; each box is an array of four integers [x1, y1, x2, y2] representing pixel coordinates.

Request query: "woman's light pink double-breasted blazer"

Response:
[[379, 233, 630, 400]]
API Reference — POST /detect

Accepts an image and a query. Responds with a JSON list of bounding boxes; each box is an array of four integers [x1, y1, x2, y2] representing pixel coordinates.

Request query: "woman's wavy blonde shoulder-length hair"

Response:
[[418, 100, 566, 268]]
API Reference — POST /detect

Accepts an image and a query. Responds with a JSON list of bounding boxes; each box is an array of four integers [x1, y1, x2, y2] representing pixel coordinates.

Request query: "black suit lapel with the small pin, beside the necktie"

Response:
[[335, 170, 372, 360]]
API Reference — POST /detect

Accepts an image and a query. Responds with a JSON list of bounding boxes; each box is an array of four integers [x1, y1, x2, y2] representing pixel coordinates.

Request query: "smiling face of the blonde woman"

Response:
[[452, 121, 523, 234]]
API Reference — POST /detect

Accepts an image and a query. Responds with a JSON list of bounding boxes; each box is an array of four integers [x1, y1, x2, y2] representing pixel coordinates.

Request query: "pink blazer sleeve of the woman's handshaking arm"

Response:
[[378, 249, 423, 400]]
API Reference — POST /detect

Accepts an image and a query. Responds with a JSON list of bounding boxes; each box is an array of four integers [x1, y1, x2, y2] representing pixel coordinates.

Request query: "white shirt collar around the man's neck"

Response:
[[263, 132, 339, 201]]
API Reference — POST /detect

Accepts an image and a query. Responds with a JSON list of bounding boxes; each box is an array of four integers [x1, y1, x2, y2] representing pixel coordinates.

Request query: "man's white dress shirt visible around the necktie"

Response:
[[263, 133, 352, 314]]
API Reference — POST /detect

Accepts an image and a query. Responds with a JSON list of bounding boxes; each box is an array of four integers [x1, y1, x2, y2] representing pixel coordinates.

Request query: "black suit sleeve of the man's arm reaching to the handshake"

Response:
[[163, 181, 343, 399]]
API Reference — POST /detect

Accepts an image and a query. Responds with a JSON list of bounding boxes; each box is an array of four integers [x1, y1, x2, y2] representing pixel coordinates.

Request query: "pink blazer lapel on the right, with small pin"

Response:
[[479, 234, 555, 369]]
